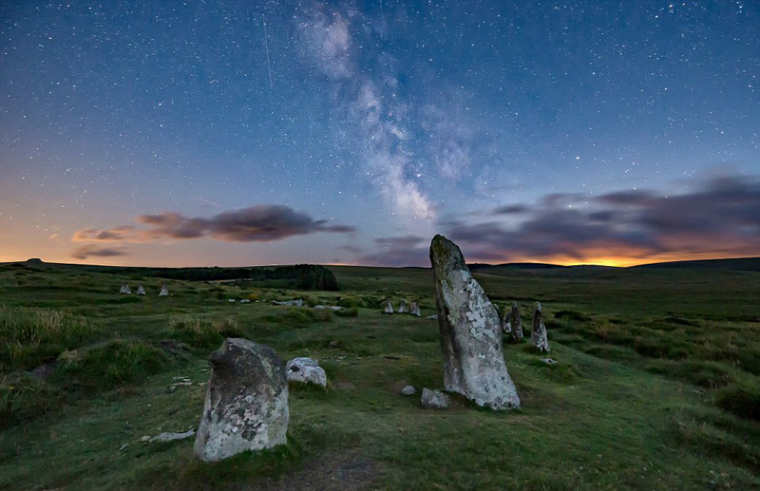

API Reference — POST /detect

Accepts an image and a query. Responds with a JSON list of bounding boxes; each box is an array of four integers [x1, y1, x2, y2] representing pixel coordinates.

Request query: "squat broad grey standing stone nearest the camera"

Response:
[[194, 338, 289, 462]]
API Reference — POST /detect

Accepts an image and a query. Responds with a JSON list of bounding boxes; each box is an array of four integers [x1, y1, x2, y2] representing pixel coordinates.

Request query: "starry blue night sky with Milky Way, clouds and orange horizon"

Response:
[[0, 0, 760, 266]]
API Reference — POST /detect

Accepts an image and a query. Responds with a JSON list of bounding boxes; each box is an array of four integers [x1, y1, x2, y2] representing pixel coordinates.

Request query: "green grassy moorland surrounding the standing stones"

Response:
[[0, 264, 760, 490]]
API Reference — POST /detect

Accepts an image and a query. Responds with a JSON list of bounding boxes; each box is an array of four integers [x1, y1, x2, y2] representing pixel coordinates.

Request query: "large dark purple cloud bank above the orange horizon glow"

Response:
[[446, 175, 760, 262]]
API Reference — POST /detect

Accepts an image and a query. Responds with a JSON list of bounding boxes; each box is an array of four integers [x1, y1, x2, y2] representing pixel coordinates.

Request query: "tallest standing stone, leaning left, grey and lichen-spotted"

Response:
[[430, 235, 520, 409]]
